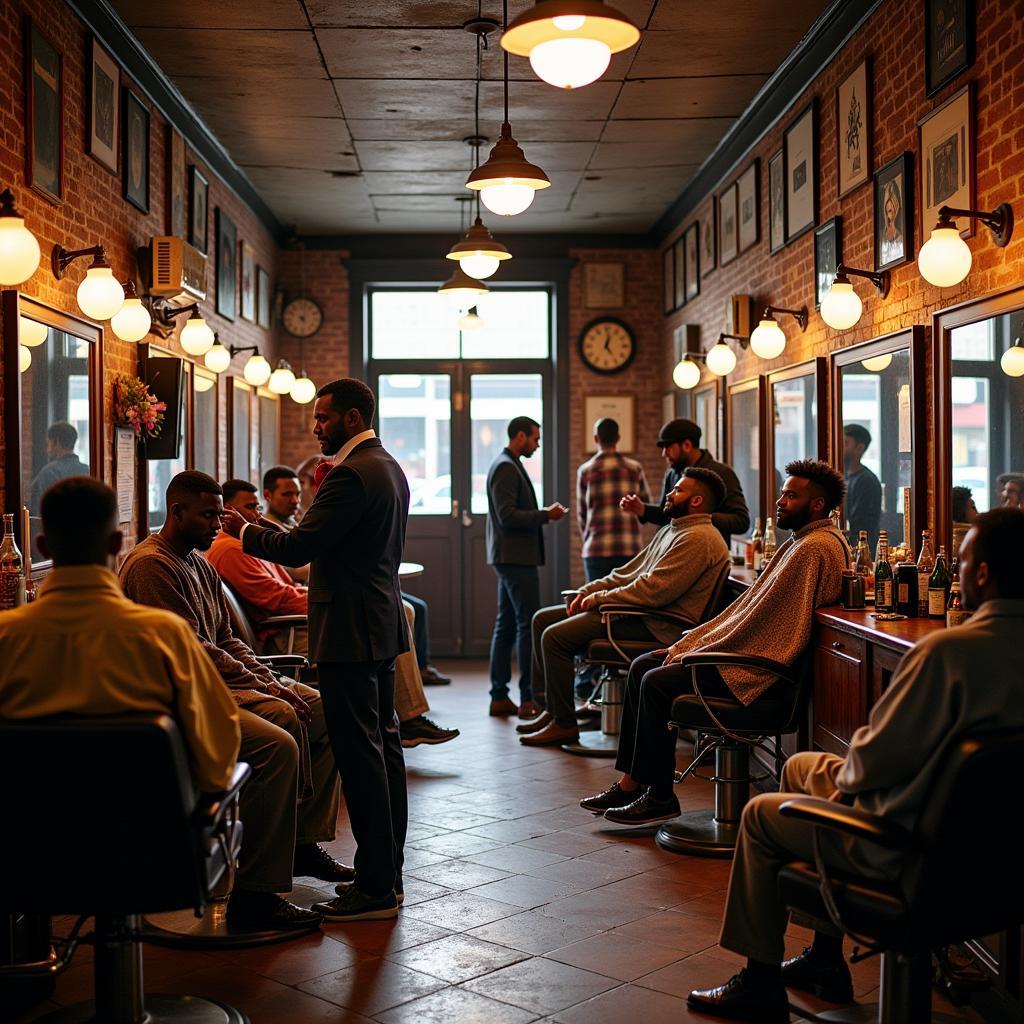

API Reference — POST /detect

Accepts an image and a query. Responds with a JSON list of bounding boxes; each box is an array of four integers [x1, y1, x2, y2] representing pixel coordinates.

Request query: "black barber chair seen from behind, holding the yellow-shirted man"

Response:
[[0, 715, 249, 1024]]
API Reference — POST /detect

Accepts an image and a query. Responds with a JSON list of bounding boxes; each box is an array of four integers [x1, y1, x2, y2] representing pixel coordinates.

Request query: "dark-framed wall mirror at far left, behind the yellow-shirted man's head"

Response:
[[3, 291, 103, 567]]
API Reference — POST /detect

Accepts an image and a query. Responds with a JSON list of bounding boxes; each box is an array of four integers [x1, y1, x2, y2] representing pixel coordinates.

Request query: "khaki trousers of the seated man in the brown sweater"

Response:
[[236, 683, 341, 893]]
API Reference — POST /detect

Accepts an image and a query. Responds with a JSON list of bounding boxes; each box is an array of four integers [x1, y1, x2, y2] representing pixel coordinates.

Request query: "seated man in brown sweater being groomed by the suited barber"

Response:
[[121, 470, 354, 930]]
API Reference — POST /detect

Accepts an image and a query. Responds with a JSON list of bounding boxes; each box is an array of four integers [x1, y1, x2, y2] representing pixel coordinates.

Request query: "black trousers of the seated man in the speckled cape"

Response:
[[615, 653, 731, 794]]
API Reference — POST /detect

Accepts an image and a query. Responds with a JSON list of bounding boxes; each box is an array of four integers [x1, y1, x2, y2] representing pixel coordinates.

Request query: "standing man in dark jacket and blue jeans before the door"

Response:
[[487, 416, 568, 718]]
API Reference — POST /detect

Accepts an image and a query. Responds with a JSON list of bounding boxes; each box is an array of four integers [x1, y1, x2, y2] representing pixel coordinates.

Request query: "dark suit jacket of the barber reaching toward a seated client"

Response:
[[242, 437, 409, 662]]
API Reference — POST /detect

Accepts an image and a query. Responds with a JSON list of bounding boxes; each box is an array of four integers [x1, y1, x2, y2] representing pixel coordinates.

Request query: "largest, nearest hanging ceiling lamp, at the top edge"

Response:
[[502, 0, 640, 89]]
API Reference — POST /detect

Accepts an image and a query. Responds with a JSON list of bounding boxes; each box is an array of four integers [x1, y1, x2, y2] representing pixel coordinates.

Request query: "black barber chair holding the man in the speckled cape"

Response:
[[654, 651, 813, 857]]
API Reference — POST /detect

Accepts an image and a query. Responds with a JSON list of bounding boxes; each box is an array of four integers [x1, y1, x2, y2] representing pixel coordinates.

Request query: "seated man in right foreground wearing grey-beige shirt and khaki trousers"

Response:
[[689, 509, 1024, 1024]]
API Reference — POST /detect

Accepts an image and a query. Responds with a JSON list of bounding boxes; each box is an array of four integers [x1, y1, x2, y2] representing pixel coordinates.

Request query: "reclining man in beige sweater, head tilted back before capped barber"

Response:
[[518, 466, 729, 746]]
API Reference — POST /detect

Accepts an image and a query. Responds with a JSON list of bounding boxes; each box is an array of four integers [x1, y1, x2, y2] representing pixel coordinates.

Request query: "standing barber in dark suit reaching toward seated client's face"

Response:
[[224, 378, 409, 921]]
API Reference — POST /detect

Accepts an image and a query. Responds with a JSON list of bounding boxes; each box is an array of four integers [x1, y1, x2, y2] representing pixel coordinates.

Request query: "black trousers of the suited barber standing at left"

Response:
[[317, 658, 409, 896]]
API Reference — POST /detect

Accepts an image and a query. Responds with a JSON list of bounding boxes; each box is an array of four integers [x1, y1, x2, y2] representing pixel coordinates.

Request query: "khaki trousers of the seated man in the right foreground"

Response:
[[720, 753, 886, 964]]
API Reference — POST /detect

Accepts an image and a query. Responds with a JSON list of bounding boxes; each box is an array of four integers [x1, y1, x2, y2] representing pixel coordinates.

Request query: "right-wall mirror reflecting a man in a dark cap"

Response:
[[831, 327, 928, 553]]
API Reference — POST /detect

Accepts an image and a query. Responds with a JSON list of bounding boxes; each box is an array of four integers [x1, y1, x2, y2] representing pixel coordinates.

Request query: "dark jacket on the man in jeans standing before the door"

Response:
[[487, 449, 548, 565]]
